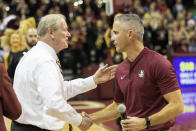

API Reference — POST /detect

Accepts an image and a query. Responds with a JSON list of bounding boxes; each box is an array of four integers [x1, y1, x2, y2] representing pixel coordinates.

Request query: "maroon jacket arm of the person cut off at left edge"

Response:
[[0, 63, 22, 131]]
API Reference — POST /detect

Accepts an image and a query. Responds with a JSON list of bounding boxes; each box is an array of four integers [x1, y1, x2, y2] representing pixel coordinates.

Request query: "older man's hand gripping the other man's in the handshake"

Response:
[[78, 112, 93, 131]]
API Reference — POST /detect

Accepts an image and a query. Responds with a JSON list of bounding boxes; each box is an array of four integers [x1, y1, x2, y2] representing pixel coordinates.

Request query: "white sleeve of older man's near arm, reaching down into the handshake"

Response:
[[35, 61, 82, 126]]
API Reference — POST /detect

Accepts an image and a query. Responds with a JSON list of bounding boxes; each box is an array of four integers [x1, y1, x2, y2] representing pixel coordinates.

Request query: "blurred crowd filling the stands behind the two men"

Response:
[[0, 0, 196, 75]]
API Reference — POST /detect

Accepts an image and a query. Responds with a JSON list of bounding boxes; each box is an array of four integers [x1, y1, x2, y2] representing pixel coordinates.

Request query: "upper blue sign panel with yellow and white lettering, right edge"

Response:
[[173, 56, 196, 88]]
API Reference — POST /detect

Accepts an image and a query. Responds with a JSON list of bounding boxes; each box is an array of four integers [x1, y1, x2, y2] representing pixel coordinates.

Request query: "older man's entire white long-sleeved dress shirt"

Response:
[[13, 41, 97, 130]]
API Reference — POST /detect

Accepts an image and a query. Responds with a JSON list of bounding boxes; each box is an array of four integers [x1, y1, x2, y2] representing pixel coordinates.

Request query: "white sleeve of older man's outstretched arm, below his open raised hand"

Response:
[[63, 76, 97, 100]]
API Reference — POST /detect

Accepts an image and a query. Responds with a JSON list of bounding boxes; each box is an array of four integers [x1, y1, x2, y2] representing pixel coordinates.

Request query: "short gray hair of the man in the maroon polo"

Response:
[[114, 14, 144, 41]]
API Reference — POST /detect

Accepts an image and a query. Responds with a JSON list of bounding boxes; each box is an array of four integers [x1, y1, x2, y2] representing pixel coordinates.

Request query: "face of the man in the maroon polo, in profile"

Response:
[[112, 21, 130, 52]]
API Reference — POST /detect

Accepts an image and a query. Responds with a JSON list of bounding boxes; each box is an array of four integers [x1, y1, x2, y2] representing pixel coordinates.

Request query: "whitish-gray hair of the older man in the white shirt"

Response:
[[37, 14, 65, 38]]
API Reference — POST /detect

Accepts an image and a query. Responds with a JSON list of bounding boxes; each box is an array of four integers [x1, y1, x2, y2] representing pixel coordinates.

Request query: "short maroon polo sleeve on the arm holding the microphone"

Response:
[[154, 58, 179, 95]]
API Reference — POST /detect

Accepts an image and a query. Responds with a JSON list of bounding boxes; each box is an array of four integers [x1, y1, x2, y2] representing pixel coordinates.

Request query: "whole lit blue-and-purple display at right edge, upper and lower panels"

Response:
[[172, 54, 196, 114]]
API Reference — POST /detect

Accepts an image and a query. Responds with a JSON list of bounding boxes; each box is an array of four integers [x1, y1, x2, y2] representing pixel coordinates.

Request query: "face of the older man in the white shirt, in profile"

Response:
[[54, 20, 71, 52]]
